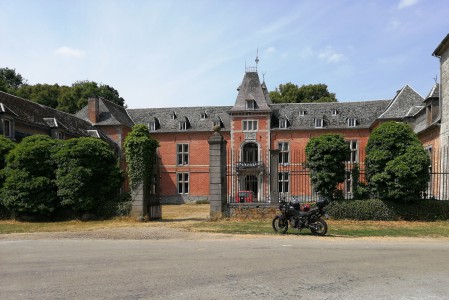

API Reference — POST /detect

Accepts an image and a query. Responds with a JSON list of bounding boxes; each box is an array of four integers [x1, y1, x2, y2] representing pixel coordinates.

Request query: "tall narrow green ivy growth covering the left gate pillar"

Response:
[[125, 124, 161, 219]]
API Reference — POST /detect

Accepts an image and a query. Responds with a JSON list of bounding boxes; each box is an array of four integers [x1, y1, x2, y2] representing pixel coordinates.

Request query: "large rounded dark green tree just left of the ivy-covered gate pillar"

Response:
[[54, 137, 123, 214]]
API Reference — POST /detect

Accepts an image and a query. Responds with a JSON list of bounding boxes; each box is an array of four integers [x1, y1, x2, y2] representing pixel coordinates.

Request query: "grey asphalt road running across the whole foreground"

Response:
[[0, 236, 449, 299]]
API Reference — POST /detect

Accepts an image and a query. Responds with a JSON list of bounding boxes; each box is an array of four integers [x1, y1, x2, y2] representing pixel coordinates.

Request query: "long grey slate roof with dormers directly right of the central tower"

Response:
[[271, 100, 391, 130]]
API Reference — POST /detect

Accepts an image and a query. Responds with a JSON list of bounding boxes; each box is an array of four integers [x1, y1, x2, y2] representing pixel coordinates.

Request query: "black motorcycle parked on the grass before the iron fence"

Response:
[[272, 199, 329, 236]]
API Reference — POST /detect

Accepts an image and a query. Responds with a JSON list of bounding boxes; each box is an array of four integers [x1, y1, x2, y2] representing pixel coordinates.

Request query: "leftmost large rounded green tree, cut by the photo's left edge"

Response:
[[1, 135, 59, 216]]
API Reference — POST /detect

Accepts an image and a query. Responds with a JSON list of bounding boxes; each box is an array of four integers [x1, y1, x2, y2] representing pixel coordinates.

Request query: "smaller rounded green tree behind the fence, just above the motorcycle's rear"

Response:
[[306, 134, 350, 200]]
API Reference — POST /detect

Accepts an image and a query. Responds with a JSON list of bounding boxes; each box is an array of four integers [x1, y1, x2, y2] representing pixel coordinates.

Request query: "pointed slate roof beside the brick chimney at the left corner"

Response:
[[76, 98, 134, 127]]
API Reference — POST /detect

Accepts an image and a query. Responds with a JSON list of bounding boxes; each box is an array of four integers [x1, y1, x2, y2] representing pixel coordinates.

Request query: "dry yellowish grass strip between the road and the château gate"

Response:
[[0, 204, 449, 237]]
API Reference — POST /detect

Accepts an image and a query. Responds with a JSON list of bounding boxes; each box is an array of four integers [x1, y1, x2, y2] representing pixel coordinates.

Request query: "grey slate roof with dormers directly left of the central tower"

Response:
[[128, 106, 232, 132]]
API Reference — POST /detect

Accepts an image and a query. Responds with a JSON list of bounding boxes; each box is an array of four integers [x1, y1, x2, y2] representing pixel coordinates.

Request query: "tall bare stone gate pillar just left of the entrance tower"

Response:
[[208, 131, 227, 219]]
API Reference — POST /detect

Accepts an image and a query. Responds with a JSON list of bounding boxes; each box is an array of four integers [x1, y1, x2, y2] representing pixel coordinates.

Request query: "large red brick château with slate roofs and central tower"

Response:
[[0, 35, 449, 203]]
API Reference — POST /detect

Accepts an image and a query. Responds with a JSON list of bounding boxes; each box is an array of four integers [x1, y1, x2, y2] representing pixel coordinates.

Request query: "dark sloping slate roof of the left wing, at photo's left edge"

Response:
[[0, 92, 94, 136]]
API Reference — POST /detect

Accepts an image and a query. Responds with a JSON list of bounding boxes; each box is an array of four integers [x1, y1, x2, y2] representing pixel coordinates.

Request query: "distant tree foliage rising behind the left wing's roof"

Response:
[[0, 68, 125, 113]]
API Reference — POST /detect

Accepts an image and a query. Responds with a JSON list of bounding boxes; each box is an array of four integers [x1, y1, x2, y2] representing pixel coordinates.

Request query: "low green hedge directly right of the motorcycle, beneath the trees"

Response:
[[326, 199, 396, 221]]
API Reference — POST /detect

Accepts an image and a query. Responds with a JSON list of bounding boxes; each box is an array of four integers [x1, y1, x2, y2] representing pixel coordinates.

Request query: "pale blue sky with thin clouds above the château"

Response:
[[0, 0, 449, 108]]
